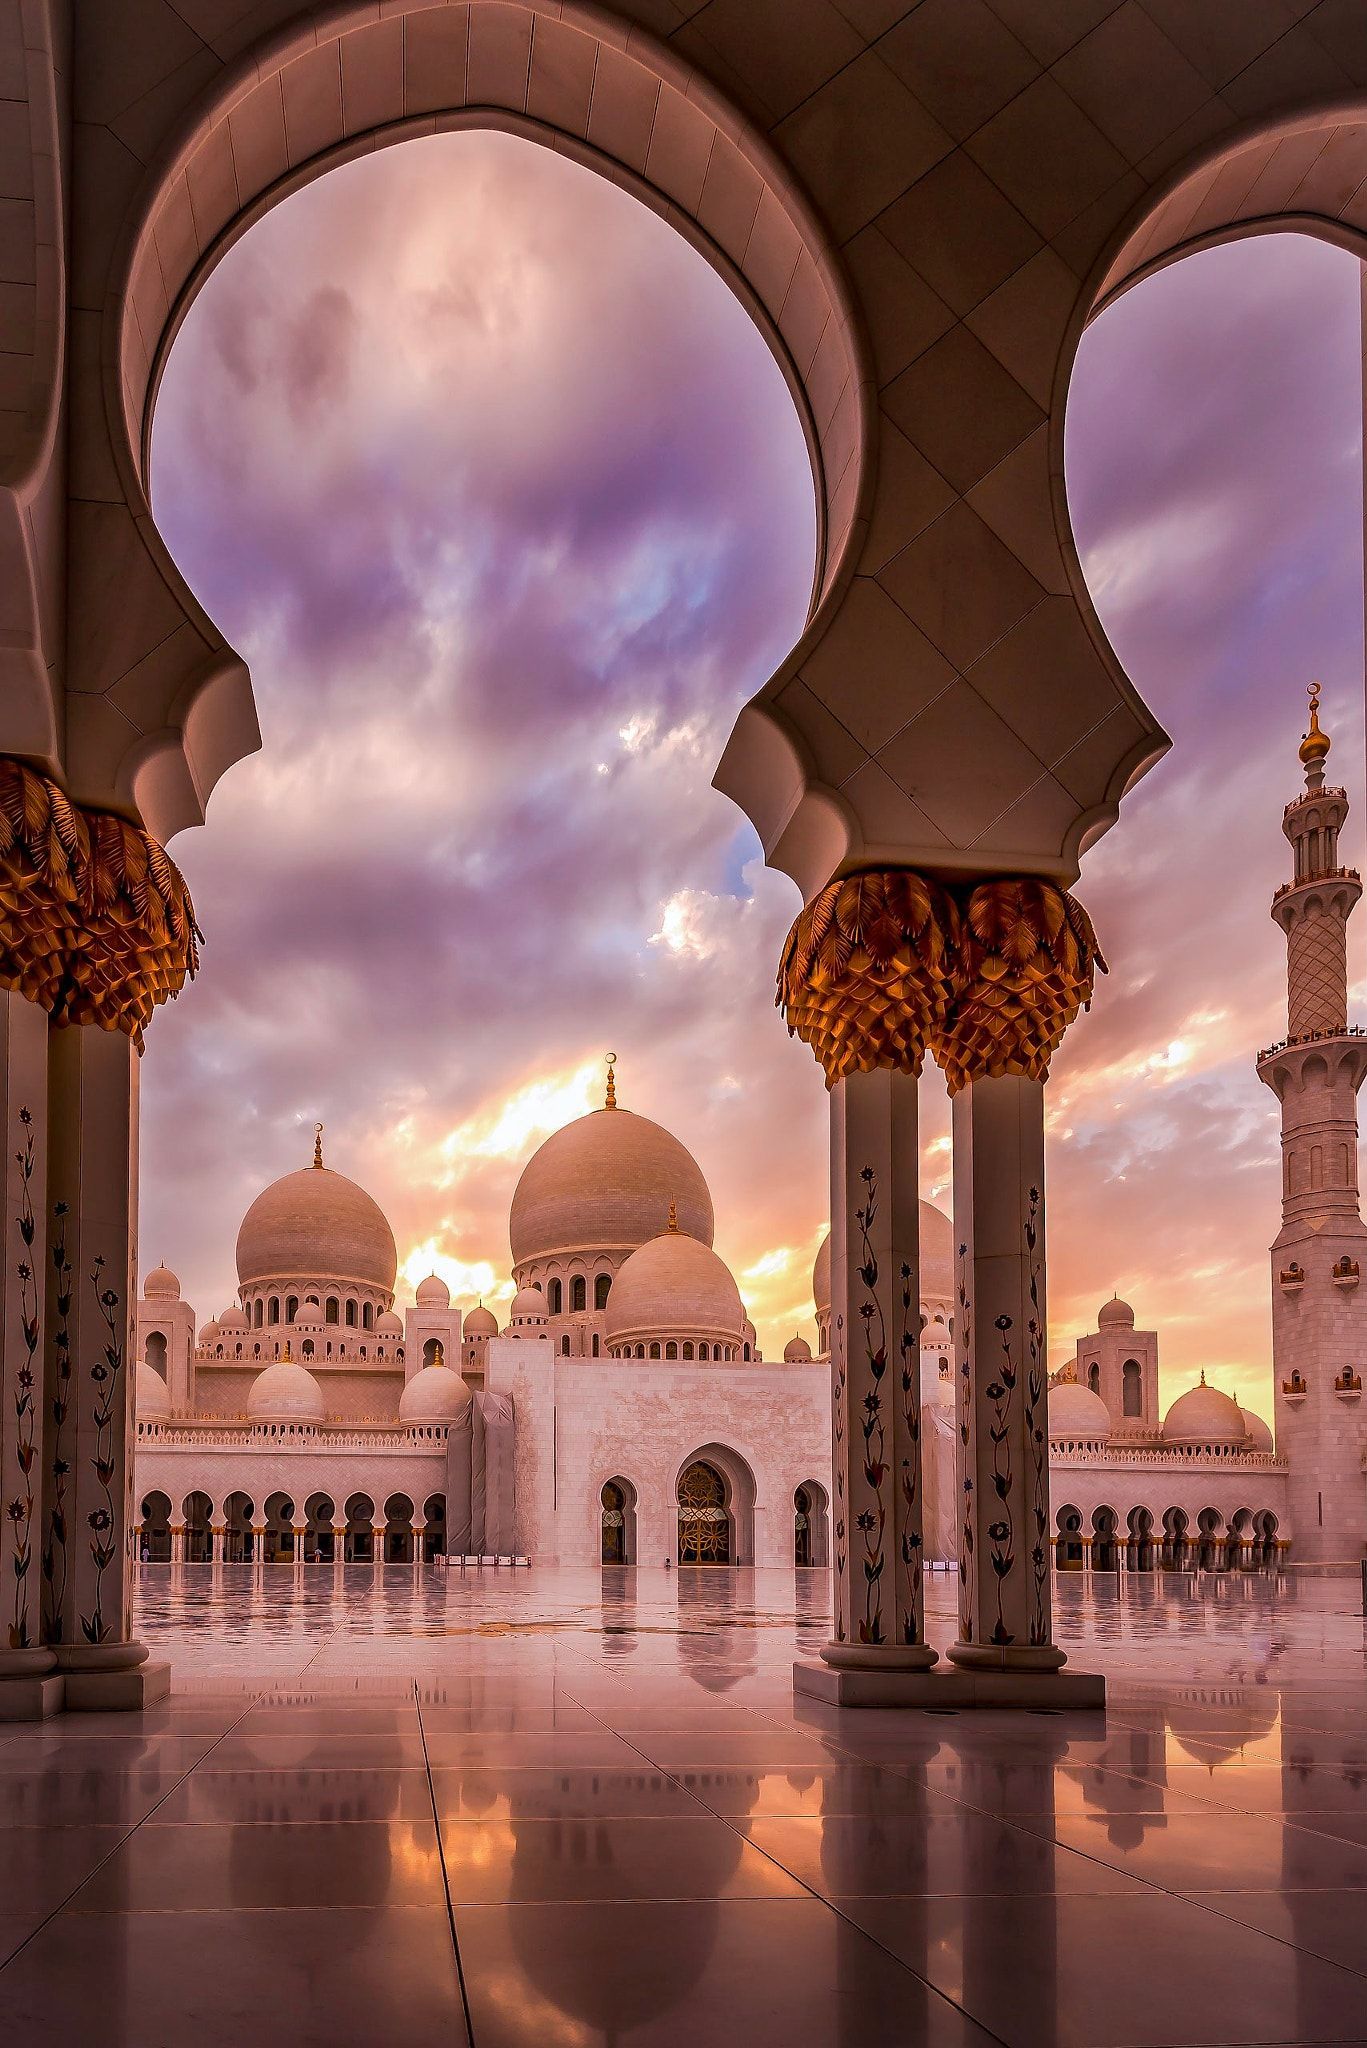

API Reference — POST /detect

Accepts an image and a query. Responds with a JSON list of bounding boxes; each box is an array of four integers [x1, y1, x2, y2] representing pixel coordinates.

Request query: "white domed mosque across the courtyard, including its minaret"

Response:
[[133, 709, 1367, 1571]]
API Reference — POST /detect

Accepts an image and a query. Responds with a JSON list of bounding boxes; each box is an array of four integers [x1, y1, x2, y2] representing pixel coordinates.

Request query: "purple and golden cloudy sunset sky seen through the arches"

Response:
[[141, 133, 1363, 1409]]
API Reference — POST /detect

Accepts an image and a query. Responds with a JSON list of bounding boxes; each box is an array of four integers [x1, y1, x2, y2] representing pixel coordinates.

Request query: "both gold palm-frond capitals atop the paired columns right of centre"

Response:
[[777, 868, 1107, 1096]]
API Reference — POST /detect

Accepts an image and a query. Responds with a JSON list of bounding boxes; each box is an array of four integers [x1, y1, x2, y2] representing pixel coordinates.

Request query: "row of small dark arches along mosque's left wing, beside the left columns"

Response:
[[137, 1489, 447, 1565]]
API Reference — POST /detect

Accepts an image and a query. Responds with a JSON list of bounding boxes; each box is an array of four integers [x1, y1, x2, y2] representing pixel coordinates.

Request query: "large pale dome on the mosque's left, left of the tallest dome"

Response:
[[238, 1165, 398, 1294]]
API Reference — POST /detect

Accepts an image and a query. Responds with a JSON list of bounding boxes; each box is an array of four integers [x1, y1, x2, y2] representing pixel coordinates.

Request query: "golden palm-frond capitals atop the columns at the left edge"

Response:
[[0, 756, 201, 1051]]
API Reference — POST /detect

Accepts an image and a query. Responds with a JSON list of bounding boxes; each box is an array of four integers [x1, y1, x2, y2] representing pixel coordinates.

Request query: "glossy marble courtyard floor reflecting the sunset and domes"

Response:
[[0, 1567, 1367, 2048]]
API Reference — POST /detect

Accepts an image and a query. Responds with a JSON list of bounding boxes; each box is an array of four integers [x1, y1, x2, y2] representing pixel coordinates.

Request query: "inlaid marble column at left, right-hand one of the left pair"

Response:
[[45, 1024, 170, 1708]]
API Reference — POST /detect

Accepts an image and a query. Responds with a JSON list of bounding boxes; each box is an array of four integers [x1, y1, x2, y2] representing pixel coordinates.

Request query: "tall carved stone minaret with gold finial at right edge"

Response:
[[1258, 682, 1367, 1565]]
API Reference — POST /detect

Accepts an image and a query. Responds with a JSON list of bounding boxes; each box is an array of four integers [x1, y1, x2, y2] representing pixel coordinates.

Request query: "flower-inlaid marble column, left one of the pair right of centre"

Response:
[[822, 1067, 935, 1671]]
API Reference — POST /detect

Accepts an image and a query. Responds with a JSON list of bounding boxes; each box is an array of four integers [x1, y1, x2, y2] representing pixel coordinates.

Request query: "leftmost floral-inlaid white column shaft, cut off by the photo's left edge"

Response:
[[0, 989, 61, 1720]]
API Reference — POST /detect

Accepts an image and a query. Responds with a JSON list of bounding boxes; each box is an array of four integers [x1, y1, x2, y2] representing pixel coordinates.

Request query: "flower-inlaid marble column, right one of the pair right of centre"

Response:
[[949, 1073, 1066, 1671]]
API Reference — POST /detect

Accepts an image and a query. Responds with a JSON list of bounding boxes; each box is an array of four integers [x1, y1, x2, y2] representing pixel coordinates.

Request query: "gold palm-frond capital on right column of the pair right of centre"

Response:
[[933, 879, 1107, 1096]]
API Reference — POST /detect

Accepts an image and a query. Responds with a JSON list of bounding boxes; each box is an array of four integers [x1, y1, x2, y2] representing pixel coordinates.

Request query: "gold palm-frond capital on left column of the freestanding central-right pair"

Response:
[[777, 868, 959, 1087]]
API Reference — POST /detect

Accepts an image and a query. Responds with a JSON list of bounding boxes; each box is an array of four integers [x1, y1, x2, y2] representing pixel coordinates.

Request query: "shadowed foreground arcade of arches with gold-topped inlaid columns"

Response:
[[0, 0, 1367, 1728]]
